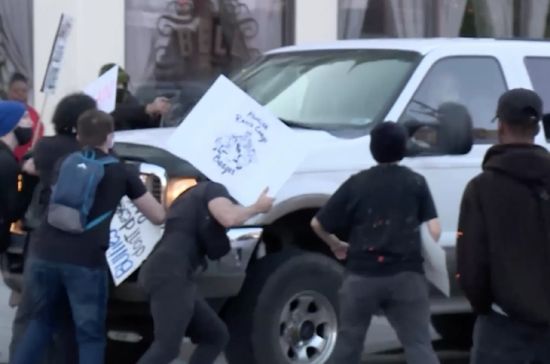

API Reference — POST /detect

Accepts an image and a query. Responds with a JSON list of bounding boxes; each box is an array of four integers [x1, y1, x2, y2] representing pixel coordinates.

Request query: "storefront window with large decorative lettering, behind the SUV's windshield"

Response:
[[126, 0, 289, 98]]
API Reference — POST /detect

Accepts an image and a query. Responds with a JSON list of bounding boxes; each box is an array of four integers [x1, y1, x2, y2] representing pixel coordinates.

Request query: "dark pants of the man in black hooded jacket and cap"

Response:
[[471, 313, 550, 364]]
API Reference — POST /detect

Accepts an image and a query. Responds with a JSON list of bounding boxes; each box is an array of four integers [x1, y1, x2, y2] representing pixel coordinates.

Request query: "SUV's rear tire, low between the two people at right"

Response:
[[432, 313, 475, 350]]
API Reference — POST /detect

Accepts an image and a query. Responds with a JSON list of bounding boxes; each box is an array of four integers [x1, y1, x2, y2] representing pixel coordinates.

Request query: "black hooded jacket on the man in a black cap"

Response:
[[457, 145, 550, 324]]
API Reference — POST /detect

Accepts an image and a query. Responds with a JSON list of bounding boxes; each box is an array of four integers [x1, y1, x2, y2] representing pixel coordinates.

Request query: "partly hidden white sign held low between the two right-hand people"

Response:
[[421, 224, 451, 297]]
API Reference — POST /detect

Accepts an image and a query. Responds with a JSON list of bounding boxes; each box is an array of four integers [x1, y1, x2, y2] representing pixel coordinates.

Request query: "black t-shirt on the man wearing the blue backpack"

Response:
[[31, 151, 147, 268]]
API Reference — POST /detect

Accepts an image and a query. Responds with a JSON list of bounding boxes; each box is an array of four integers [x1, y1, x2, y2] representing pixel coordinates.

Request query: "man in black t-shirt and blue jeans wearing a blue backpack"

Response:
[[12, 110, 165, 364]]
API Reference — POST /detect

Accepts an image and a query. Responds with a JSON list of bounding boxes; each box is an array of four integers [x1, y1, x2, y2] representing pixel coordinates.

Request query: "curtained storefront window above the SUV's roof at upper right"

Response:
[[339, 0, 550, 39]]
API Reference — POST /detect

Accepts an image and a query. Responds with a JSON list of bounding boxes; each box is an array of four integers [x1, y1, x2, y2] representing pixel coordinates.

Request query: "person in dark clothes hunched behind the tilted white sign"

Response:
[[138, 182, 273, 364]]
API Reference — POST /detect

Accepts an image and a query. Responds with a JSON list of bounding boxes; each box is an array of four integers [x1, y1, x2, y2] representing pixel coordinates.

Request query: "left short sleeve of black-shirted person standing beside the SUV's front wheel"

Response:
[[316, 177, 353, 234]]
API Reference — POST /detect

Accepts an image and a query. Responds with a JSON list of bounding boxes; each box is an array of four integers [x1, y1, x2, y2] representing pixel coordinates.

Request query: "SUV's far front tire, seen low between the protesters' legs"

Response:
[[105, 322, 153, 364]]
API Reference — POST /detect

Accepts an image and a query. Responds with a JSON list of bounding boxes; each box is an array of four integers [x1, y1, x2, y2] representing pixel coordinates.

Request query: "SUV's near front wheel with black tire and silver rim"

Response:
[[225, 253, 343, 364]]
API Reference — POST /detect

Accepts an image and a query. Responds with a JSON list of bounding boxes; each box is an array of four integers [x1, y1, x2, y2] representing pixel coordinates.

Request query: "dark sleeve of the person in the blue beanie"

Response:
[[0, 153, 20, 223]]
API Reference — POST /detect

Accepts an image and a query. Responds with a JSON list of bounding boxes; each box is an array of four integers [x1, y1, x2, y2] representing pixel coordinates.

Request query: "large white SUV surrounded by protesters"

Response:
[[8, 39, 550, 364]]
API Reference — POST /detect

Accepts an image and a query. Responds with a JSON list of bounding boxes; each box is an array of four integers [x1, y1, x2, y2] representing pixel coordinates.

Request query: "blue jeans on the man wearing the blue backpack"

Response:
[[11, 259, 108, 364]]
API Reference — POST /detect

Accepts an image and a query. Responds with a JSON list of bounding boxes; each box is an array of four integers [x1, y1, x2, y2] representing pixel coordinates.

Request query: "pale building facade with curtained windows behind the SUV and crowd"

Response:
[[0, 0, 550, 131]]
